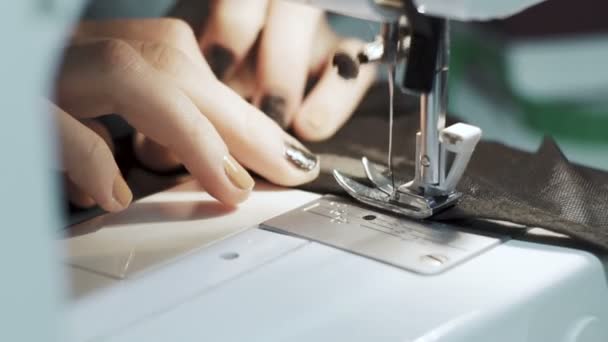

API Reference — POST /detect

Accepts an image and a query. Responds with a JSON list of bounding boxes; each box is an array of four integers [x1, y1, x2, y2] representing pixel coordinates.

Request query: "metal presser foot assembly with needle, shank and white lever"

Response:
[[333, 19, 481, 219]]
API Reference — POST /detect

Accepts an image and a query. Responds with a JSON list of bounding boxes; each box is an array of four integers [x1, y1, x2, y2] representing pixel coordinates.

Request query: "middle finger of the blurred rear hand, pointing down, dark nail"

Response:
[[257, 0, 322, 128]]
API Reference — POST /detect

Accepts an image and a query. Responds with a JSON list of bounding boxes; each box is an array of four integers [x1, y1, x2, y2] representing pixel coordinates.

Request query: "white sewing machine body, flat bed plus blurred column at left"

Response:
[[0, 0, 608, 342]]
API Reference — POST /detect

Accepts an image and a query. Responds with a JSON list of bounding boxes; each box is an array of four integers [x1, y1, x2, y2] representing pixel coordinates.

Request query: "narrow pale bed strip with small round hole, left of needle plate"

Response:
[[68, 227, 306, 341]]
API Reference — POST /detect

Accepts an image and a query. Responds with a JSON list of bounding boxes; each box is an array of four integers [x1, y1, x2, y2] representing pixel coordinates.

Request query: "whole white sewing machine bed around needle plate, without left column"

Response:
[[66, 183, 608, 342]]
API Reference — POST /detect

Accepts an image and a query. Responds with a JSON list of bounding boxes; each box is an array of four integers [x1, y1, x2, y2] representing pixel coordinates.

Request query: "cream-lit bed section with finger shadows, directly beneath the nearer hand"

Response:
[[62, 182, 318, 279]]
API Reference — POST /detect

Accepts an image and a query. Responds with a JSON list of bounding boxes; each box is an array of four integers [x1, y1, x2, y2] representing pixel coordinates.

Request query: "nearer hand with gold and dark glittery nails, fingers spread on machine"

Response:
[[52, 19, 319, 211]]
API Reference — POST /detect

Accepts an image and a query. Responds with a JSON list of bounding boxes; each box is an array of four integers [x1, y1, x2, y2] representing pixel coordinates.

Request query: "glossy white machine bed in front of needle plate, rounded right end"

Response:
[[111, 242, 608, 342]]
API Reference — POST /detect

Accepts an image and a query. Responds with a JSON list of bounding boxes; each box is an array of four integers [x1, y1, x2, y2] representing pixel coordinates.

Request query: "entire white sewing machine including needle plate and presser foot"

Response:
[[0, 0, 608, 342]]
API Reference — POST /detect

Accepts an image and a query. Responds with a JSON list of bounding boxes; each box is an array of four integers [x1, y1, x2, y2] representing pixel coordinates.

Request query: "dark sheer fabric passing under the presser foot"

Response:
[[304, 86, 608, 251]]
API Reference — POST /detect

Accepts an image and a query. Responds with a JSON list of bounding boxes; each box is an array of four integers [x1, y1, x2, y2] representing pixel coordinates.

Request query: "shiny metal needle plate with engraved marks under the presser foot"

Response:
[[261, 195, 504, 275]]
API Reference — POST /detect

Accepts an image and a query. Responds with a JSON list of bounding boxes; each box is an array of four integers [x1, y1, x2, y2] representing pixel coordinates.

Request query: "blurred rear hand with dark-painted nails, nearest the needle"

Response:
[[200, 0, 375, 140]]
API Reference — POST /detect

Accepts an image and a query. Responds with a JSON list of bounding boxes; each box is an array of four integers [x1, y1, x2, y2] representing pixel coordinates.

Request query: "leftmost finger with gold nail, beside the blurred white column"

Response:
[[51, 101, 133, 211]]
